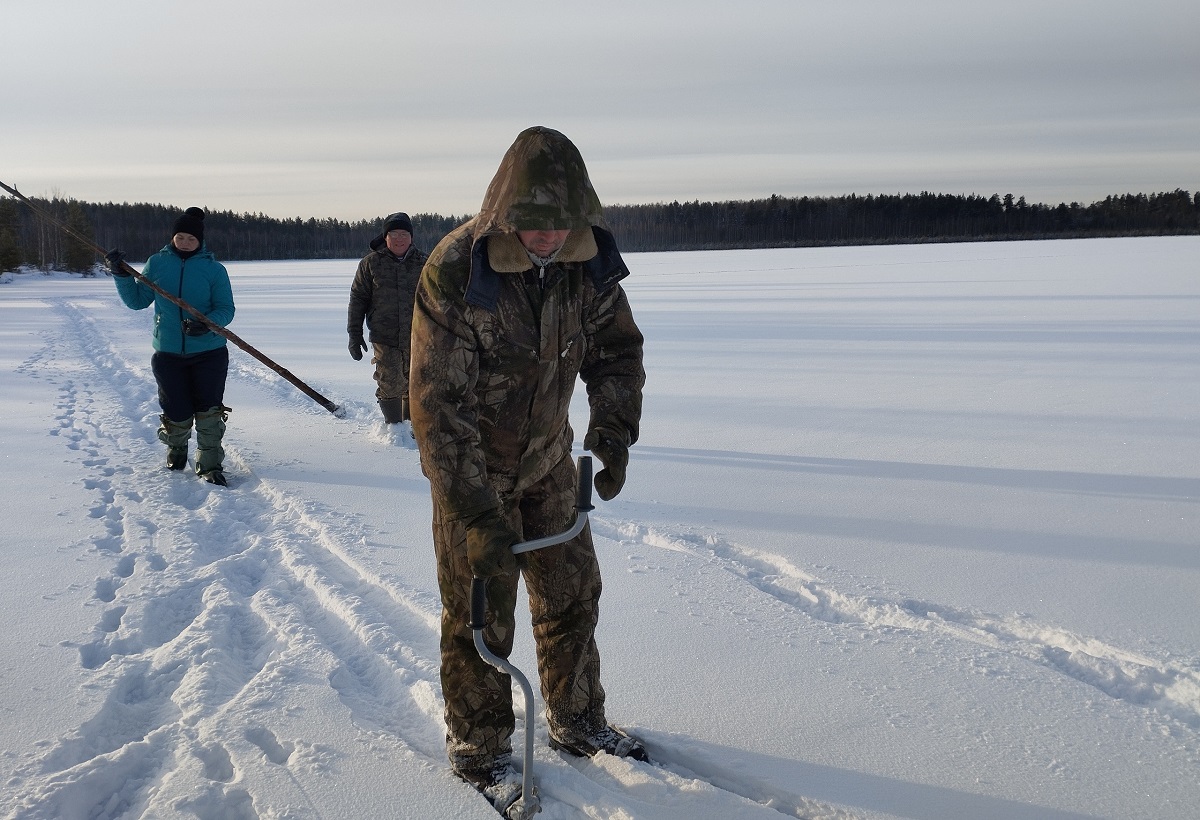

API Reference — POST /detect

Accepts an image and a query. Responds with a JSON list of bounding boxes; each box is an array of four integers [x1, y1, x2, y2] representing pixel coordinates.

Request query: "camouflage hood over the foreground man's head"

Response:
[[473, 125, 607, 241]]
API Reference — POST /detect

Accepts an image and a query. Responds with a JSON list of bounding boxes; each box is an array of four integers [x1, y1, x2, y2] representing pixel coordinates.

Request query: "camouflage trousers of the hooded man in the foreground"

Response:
[[433, 455, 606, 772]]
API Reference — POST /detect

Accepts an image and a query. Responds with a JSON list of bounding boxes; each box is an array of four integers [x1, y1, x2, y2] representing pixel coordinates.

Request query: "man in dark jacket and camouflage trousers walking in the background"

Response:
[[346, 213, 427, 424]]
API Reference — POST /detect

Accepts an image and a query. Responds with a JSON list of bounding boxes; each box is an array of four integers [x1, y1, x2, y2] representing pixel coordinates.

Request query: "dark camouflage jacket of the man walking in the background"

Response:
[[346, 238, 427, 347]]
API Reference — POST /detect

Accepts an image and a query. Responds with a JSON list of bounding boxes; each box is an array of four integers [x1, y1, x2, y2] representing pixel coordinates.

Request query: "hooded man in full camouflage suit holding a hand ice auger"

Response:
[[409, 127, 646, 813]]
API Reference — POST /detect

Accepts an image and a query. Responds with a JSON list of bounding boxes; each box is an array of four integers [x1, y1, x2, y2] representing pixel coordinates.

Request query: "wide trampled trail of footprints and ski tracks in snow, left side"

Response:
[[6, 300, 853, 820]]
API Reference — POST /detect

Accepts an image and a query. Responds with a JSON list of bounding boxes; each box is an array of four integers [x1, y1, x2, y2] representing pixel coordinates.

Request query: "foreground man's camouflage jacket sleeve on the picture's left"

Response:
[[408, 259, 500, 520]]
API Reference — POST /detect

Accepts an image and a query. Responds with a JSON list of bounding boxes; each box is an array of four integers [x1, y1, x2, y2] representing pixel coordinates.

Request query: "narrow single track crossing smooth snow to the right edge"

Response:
[[592, 516, 1200, 730]]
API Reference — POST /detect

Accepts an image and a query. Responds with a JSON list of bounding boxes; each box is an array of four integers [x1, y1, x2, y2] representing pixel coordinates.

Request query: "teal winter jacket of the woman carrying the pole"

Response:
[[115, 243, 234, 355]]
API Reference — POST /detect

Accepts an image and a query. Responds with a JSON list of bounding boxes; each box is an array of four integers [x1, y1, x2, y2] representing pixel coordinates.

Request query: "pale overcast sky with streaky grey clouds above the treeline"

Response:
[[0, 0, 1200, 220]]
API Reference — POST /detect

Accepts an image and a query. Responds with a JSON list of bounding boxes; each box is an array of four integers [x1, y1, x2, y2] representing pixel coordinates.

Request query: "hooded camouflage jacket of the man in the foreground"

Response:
[[409, 130, 646, 519]]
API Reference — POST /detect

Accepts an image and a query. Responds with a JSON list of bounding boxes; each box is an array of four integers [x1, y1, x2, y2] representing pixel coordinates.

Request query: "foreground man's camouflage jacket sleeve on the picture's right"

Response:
[[580, 285, 646, 445]]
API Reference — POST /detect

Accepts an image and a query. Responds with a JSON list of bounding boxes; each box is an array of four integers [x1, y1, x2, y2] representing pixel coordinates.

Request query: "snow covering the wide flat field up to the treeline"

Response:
[[0, 237, 1200, 820]]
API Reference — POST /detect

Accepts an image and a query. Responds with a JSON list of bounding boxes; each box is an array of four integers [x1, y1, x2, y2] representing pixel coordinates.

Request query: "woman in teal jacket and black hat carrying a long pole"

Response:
[[106, 208, 234, 486]]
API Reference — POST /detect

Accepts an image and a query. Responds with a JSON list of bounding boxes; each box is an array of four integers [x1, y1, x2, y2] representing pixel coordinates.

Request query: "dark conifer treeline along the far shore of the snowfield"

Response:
[[0, 190, 1200, 270]]
